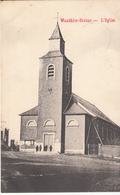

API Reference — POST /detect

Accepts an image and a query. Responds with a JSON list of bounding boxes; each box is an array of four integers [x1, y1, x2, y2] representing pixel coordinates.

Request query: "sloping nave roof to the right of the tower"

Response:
[[64, 93, 116, 125]]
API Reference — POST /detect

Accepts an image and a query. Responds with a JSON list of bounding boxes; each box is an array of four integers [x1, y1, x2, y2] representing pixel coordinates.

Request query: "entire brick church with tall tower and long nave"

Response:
[[20, 22, 120, 154]]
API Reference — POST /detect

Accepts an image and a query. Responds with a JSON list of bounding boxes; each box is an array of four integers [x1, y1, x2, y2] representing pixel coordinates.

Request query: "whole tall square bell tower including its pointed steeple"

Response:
[[37, 22, 72, 152]]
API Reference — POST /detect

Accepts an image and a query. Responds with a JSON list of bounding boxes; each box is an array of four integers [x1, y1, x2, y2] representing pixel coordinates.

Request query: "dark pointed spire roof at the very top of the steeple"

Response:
[[49, 22, 65, 42]]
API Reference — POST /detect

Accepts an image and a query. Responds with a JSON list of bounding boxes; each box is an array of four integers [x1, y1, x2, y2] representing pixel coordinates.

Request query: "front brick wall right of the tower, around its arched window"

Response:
[[65, 115, 85, 154]]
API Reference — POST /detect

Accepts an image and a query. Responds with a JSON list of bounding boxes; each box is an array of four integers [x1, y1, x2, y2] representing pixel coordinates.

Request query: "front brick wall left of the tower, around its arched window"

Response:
[[20, 116, 38, 141]]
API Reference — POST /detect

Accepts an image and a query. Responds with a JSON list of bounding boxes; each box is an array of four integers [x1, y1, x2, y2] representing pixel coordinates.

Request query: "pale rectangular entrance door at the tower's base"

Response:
[[44, 134, 53, 152]]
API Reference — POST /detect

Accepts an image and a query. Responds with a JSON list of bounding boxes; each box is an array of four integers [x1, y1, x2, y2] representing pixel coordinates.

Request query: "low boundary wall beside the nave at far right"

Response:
[[99, 145, 120, 157]]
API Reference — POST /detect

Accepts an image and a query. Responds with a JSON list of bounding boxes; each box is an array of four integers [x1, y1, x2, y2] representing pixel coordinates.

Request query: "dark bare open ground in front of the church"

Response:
[[1, 151, 120, 192]]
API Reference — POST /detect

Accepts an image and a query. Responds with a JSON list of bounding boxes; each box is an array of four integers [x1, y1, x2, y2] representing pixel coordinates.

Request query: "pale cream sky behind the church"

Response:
[[0, 0, 120, 140]]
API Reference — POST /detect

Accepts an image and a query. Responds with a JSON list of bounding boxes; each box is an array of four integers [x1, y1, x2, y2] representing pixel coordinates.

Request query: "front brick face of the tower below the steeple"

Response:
[[37, 57, 63, 148]]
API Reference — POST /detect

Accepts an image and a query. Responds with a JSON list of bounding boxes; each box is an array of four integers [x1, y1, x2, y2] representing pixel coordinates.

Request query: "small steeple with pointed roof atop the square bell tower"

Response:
[[49, 22, 65, 54]]
